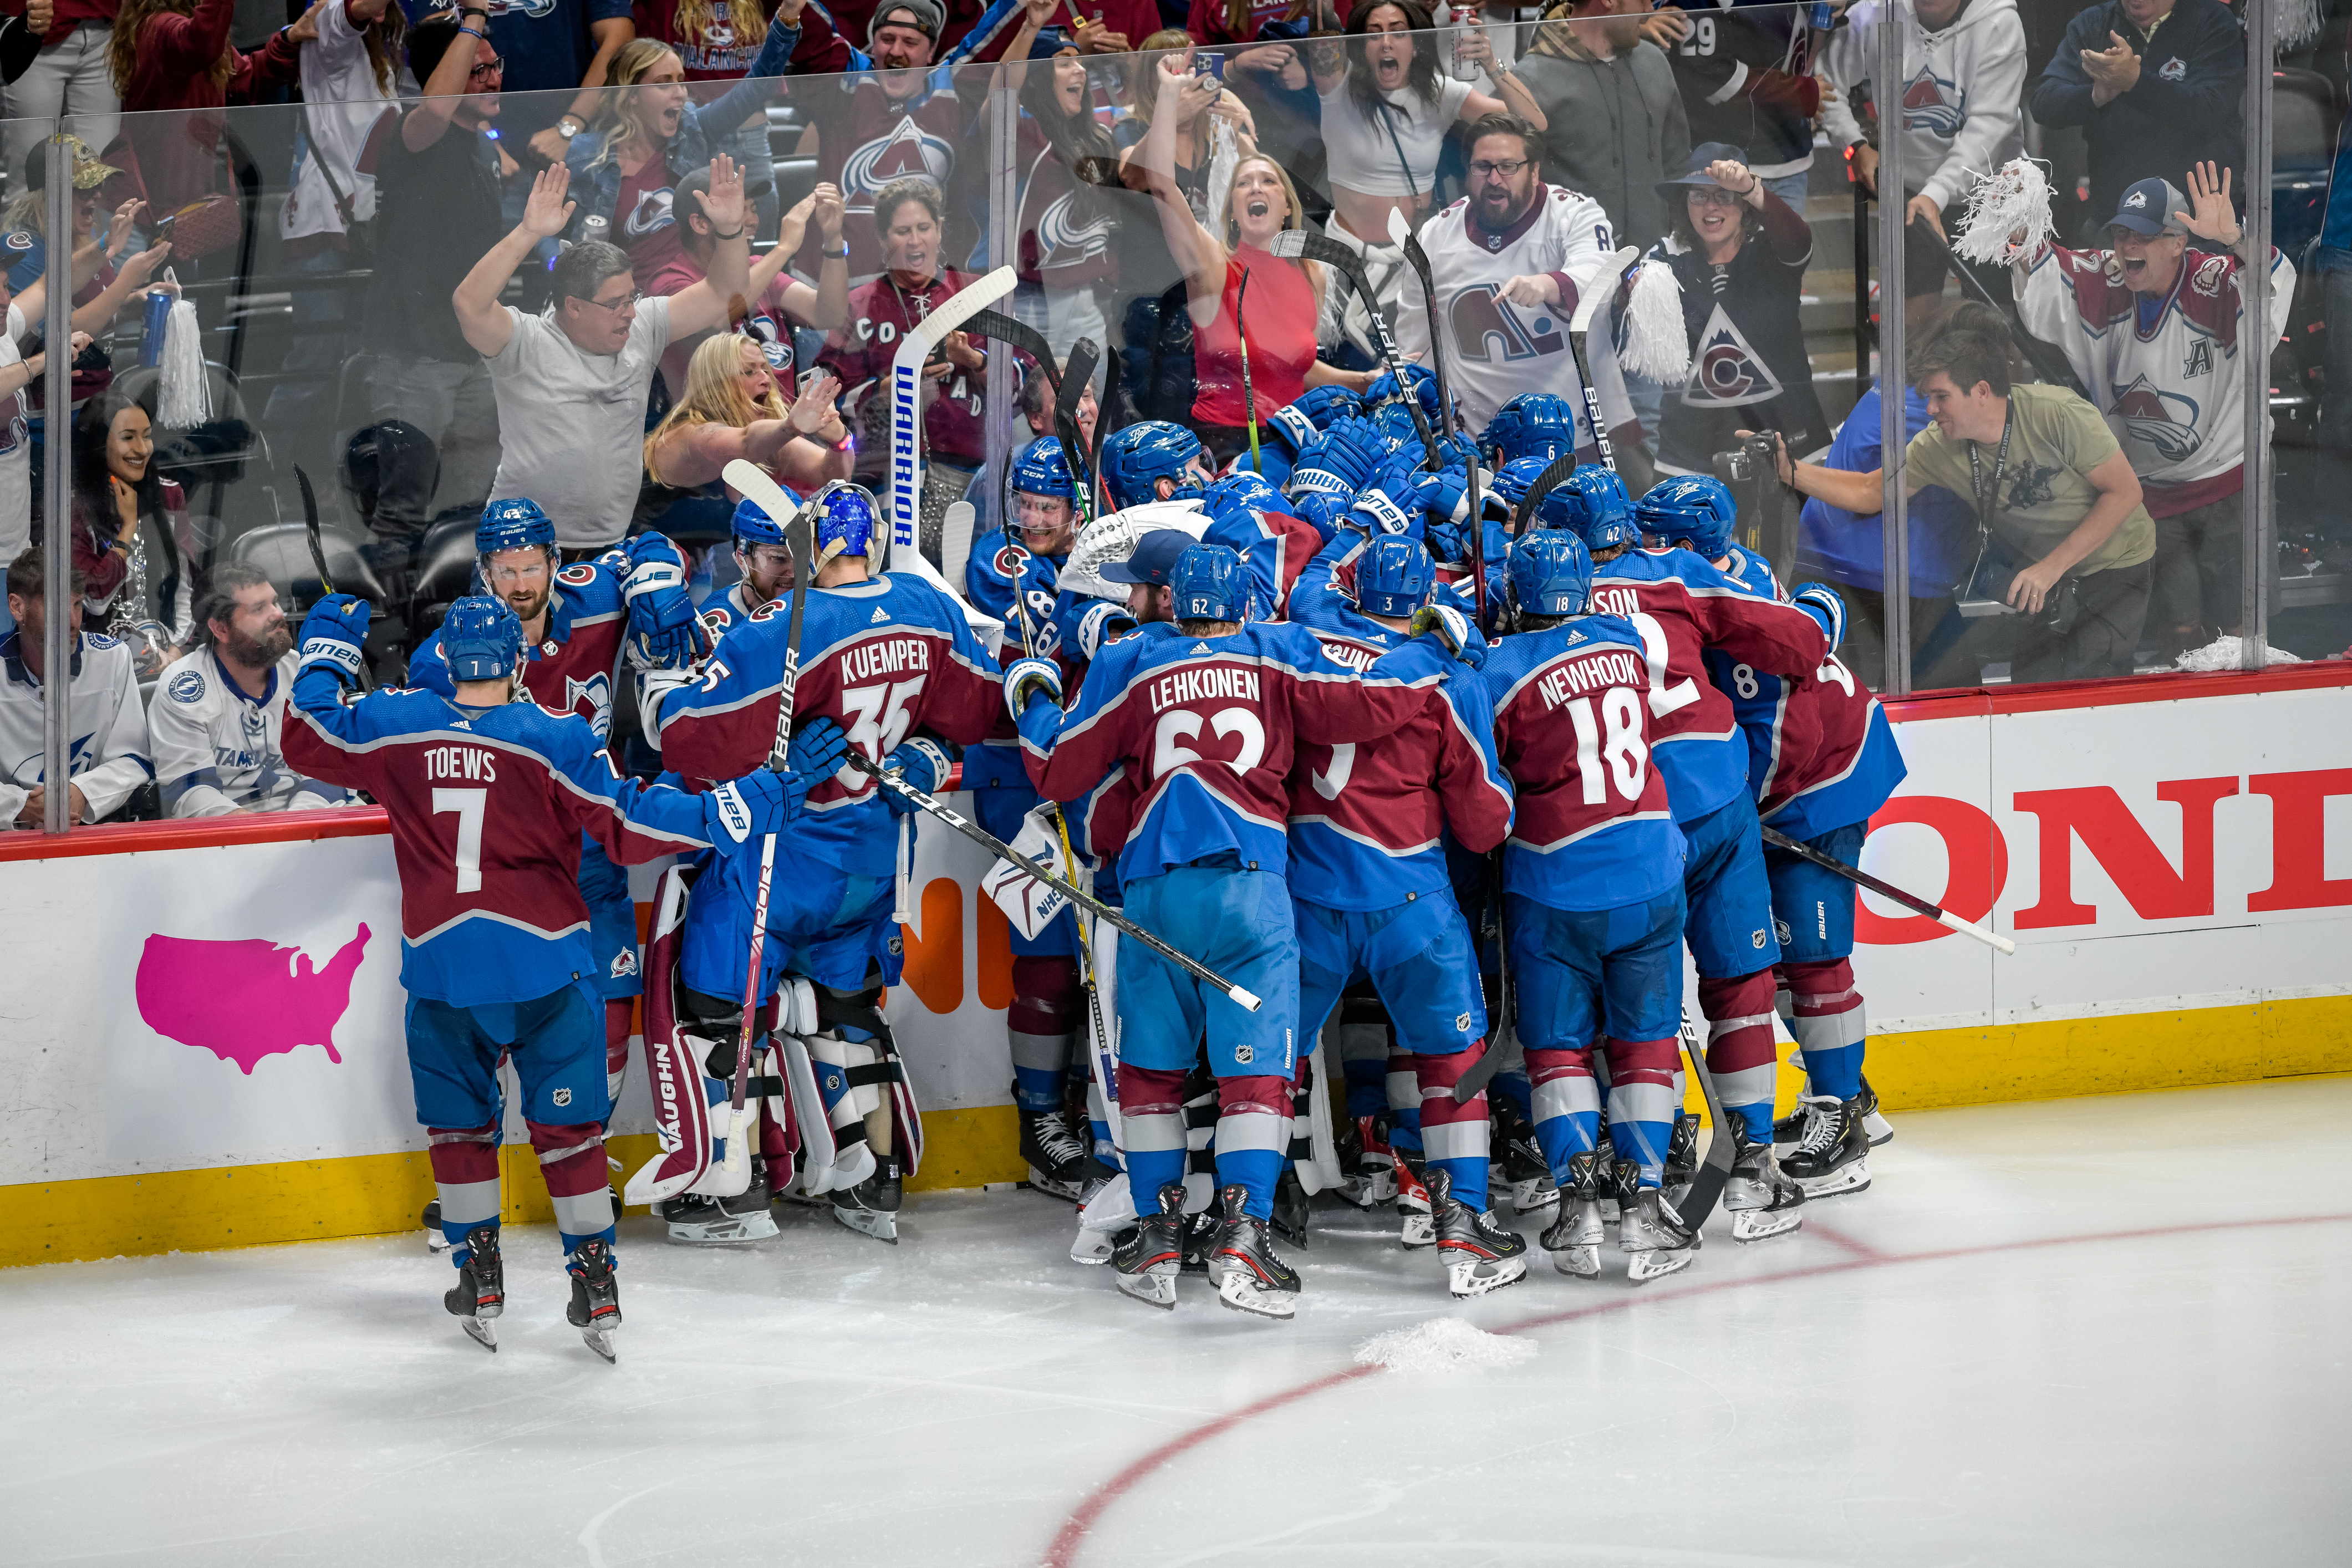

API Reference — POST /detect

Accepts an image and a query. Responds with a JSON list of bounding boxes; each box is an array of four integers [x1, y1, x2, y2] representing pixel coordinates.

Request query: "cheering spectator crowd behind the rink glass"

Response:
[[0, 0, 2324, 827]]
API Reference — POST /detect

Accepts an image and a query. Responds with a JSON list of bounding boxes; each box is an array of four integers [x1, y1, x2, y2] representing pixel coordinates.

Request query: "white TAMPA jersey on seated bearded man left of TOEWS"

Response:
[[148, 649, 350, 816]]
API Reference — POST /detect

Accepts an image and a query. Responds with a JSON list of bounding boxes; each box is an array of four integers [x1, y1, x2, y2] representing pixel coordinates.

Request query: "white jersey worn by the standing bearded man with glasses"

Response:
[[1397, 186, 1632, 447]]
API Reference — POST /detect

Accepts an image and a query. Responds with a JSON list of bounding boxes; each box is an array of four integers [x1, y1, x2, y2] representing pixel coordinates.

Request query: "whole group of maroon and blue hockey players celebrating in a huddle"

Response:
[[284, 366, 1903, 1356]]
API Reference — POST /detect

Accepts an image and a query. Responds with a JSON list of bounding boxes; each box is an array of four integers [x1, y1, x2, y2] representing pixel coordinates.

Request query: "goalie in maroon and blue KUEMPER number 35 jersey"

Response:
[[644, 482, 1002, 1241]]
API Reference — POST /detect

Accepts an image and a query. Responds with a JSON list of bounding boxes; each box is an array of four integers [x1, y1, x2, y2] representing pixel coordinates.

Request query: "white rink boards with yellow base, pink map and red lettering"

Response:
[[0, 665, 2352, 1265]]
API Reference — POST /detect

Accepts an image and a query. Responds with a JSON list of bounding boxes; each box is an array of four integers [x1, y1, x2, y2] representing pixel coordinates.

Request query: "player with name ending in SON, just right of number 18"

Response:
[[1580, 468, 1835, 1241]]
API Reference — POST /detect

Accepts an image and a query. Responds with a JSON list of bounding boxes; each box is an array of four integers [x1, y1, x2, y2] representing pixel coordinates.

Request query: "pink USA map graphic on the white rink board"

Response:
[[134, 924, 367, 1077]]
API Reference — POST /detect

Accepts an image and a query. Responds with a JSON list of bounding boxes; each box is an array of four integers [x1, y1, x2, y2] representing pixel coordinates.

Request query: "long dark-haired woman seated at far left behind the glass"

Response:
[[73, 393, 202, 679]]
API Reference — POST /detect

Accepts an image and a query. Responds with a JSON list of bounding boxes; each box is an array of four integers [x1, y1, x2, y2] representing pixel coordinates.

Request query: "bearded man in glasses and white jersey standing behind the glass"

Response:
[[1397, 115, 1640, 451]]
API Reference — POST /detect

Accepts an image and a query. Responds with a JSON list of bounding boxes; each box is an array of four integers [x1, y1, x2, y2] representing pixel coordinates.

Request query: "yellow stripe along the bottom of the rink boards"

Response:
[[0, 997, 2352, 1267]]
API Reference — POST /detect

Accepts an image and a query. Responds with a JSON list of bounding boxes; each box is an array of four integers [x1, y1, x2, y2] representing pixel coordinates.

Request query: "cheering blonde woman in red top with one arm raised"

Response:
[[1134, 61, 1371, 465]]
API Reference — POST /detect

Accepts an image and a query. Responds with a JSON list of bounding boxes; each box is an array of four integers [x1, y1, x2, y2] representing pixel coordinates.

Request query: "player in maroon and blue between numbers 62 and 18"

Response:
[[1289, 536, 1526, 1297]]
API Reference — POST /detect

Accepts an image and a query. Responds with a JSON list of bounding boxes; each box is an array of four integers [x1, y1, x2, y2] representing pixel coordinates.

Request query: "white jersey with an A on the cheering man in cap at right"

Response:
[[2015, 245, 2295, 503]]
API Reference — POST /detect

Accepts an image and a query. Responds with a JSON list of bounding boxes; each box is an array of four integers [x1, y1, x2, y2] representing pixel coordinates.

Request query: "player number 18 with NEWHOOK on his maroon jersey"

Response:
[[1484, 529, 1693, 1284]]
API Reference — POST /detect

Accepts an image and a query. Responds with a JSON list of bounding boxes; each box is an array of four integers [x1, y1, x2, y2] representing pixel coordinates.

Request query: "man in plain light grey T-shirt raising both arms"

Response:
[[451, 155, 750, 557]]
